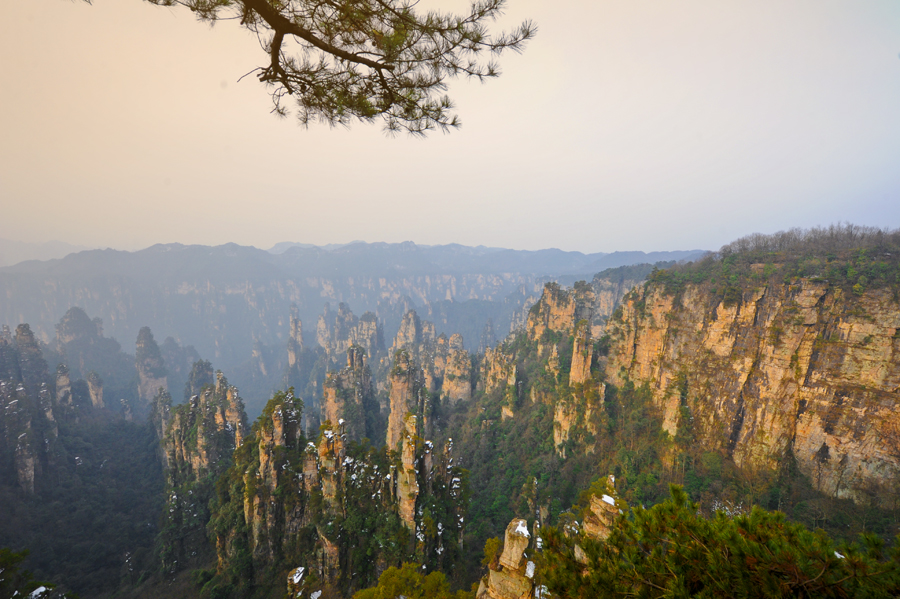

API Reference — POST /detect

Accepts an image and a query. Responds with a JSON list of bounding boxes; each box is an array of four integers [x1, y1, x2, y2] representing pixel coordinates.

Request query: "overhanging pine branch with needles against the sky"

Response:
[[96, 0, 536, 134]]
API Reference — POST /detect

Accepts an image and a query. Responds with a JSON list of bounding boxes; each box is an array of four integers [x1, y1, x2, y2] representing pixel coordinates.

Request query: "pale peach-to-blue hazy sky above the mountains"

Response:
[[0, 0, 900, 252]]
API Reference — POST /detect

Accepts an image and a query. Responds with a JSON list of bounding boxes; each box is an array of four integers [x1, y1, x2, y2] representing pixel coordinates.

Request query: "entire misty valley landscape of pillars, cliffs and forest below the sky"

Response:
[[0, 233, 900, 599]]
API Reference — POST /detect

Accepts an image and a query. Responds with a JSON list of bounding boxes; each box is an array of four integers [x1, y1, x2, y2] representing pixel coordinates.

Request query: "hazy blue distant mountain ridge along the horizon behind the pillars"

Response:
[[0, 242, 704, 406]]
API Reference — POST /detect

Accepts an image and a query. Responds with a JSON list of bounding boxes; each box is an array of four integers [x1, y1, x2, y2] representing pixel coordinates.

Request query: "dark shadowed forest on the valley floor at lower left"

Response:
[[0, 413, 163, 596]]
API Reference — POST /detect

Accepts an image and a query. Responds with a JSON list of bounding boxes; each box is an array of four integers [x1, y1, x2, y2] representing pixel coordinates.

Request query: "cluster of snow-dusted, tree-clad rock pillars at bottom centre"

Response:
[[210, 372, 464, 596]]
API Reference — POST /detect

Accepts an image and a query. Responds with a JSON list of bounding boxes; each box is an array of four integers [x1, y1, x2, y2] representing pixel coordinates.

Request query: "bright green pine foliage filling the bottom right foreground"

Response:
[[542, 485, 900, 599]]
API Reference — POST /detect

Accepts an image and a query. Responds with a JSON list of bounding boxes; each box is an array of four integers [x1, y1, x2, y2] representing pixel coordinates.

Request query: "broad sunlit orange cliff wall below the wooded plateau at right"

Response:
[[606, 279, 900, 499]]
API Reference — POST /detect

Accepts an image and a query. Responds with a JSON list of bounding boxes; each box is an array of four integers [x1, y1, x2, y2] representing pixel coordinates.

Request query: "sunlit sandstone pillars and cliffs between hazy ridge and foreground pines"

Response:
[[0, 231, 900, 599]]
